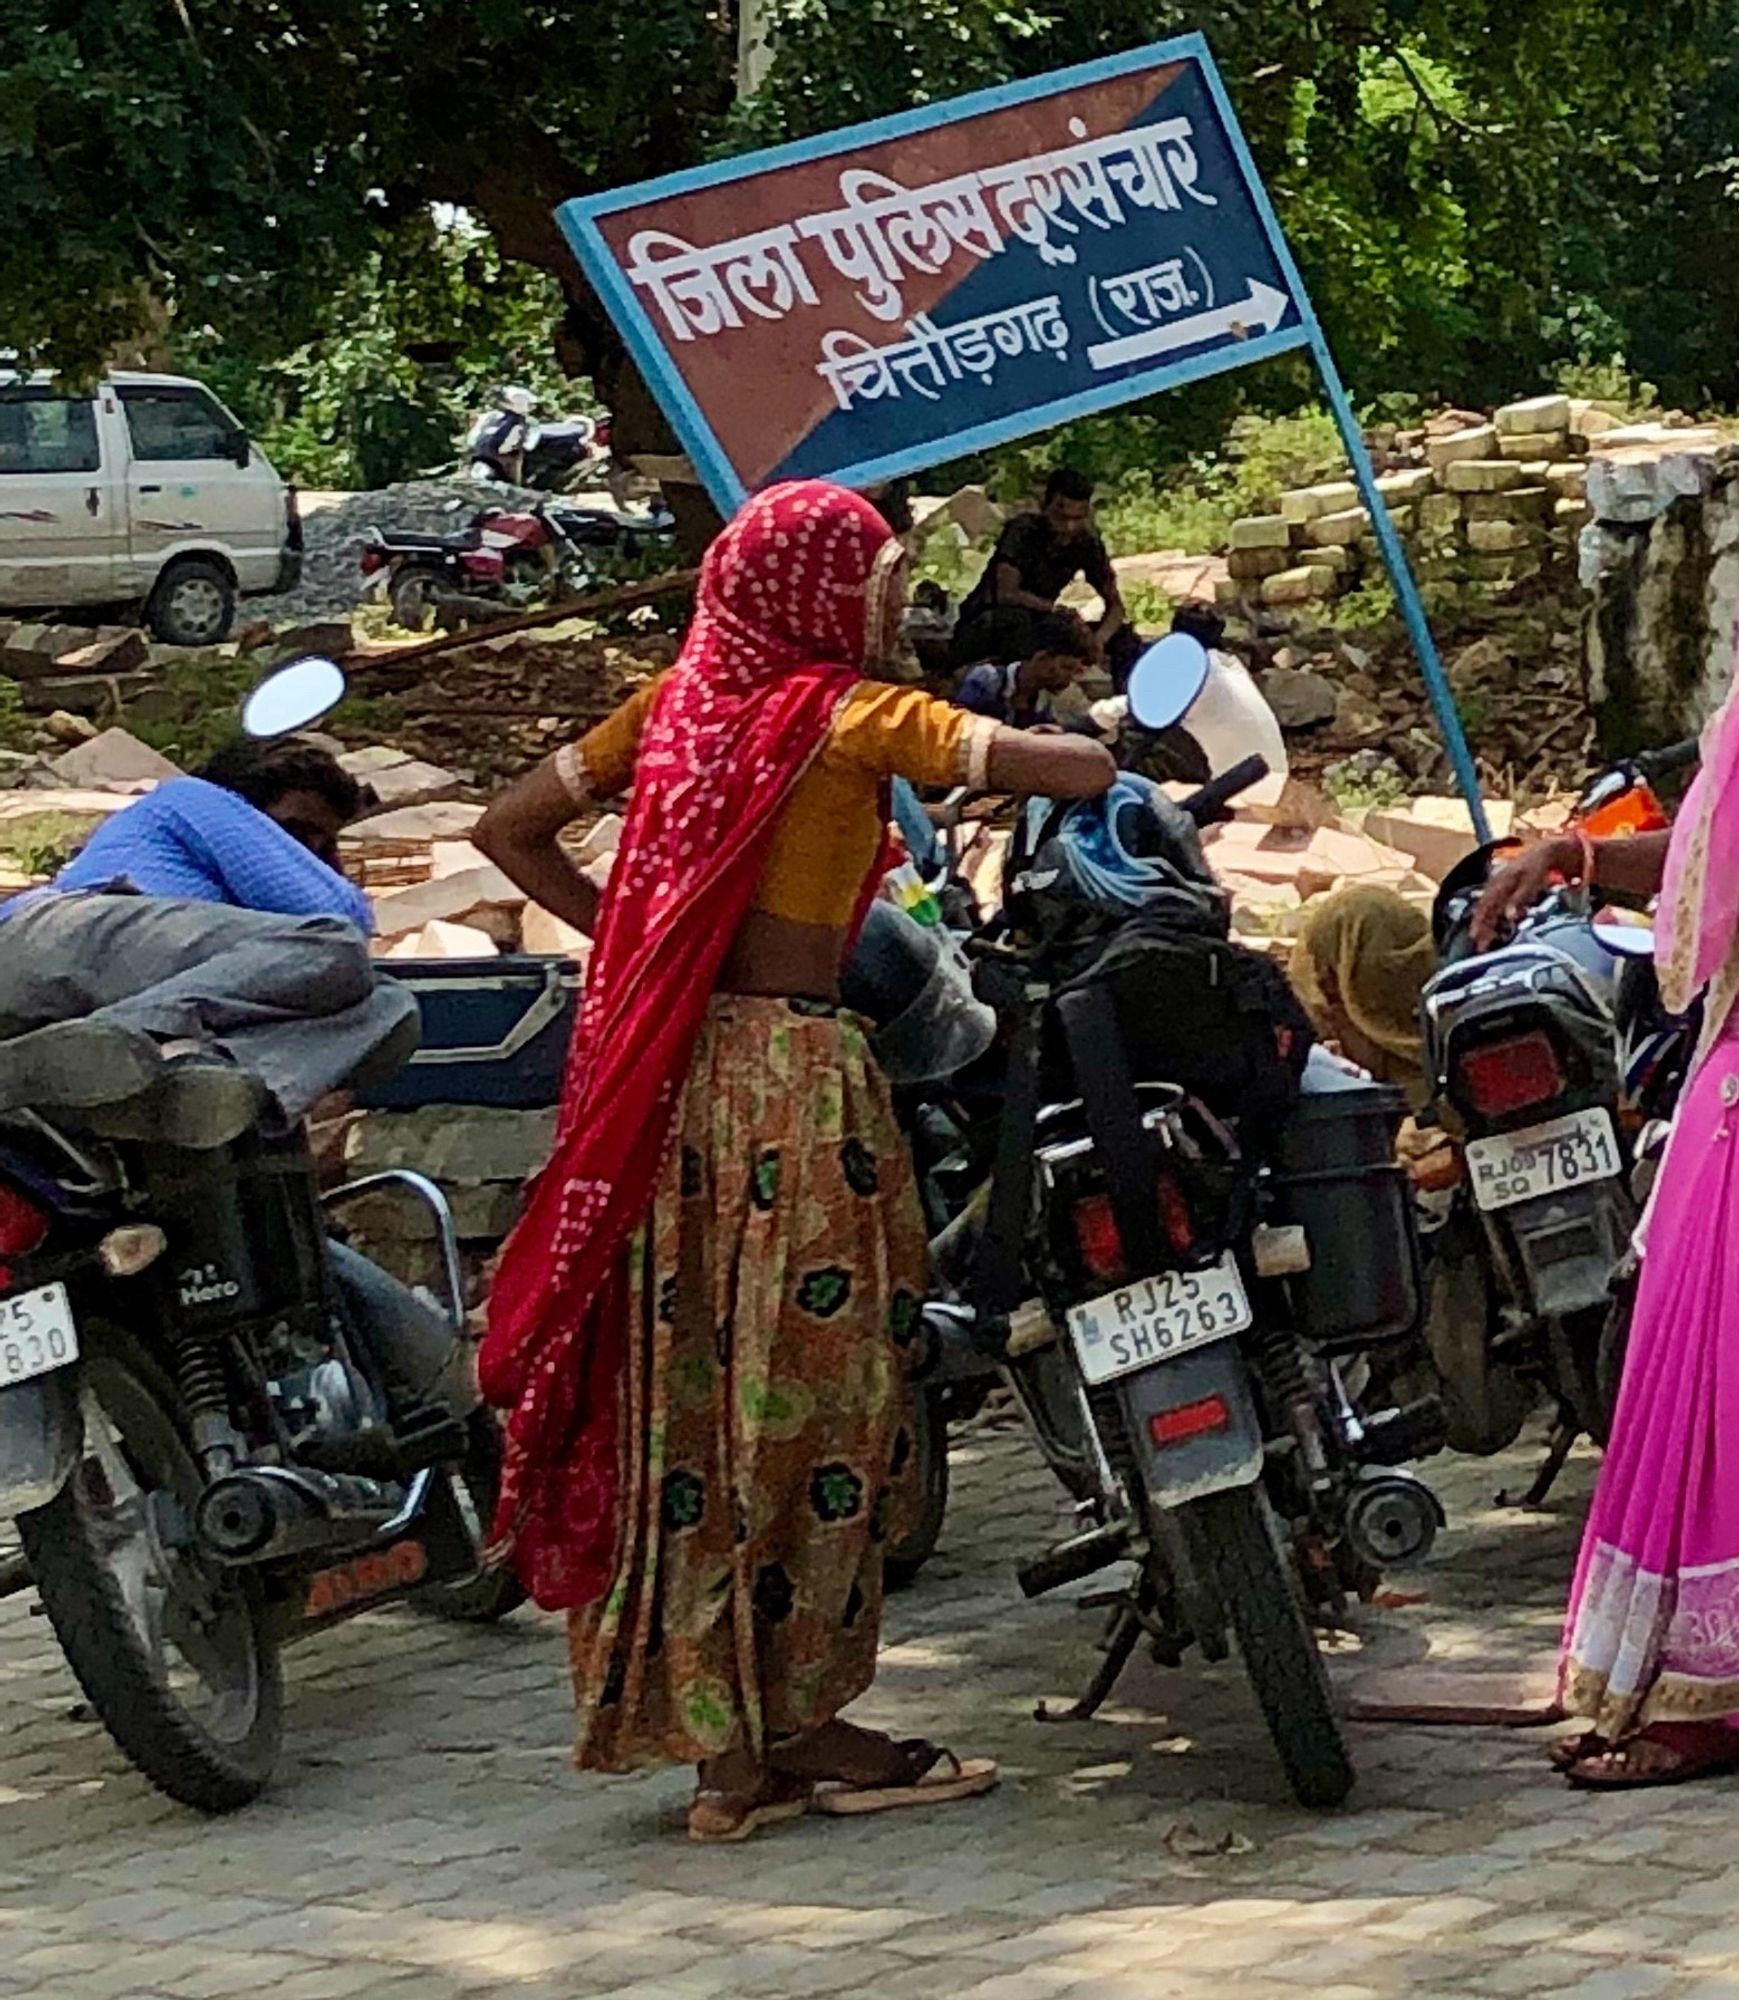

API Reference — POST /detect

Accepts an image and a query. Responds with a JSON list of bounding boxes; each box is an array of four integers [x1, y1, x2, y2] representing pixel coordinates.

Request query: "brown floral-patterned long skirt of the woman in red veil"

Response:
[[568, 994, 923, 1770]]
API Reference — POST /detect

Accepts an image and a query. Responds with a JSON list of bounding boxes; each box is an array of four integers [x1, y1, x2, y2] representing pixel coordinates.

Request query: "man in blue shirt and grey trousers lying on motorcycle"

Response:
[[0, 738, 416, 1146]]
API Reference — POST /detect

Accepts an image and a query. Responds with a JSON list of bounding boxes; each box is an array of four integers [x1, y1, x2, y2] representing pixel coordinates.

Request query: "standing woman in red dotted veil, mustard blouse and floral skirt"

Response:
[[478, 482, 1113, 1840]]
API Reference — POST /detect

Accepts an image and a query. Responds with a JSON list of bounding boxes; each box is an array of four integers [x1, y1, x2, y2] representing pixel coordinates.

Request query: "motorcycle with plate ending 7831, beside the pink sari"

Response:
[[1421, 744, 1695, 1506]]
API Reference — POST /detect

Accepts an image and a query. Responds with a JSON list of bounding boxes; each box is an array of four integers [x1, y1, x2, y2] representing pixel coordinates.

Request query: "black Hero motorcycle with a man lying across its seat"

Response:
[[0, 662, 522, 1812]]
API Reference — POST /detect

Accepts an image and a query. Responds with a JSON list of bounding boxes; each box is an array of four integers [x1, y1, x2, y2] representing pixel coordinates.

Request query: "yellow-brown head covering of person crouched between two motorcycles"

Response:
[[1291, 888, 1437, 1092]]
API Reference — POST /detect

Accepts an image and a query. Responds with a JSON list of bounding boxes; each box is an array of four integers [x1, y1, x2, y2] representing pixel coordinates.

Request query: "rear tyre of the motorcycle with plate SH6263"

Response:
[[1183, 1486, 1353, 1810]]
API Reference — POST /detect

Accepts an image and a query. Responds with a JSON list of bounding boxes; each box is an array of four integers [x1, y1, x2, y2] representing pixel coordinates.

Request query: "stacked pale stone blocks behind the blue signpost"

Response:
[[1219, 396, 1633, 610]]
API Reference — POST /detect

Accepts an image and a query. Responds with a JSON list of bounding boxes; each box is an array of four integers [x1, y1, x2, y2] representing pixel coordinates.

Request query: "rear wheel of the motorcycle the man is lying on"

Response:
[[18, 1334, 284, 1812]]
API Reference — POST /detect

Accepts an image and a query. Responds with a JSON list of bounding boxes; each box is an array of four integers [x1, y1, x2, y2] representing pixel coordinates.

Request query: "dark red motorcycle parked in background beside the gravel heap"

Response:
[[360, 500, 672, 632]]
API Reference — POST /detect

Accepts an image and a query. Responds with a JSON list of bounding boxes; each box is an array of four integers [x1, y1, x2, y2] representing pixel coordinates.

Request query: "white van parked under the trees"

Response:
[[0, 372, 302, 646]]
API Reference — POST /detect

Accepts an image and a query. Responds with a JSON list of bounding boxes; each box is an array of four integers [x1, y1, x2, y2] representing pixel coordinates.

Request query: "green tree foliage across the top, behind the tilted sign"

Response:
[[0, 0, 1739, 442]]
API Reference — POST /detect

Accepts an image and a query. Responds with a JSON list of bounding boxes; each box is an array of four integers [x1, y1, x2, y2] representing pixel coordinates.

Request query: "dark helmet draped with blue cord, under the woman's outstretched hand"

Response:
[[1007, 770, 1227, 934]]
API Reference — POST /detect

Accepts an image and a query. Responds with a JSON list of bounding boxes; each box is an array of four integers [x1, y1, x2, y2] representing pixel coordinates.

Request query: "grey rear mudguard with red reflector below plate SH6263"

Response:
[[1117, 1340, 1263, 1506]]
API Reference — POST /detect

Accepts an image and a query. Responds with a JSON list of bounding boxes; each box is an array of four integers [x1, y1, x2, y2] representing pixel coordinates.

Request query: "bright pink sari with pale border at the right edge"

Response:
[[1561, 694, 1739, 1742]]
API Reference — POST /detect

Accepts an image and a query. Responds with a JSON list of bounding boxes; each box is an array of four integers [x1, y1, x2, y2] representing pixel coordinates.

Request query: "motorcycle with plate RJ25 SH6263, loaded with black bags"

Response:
[[923, 640, 1443, 1806]]
